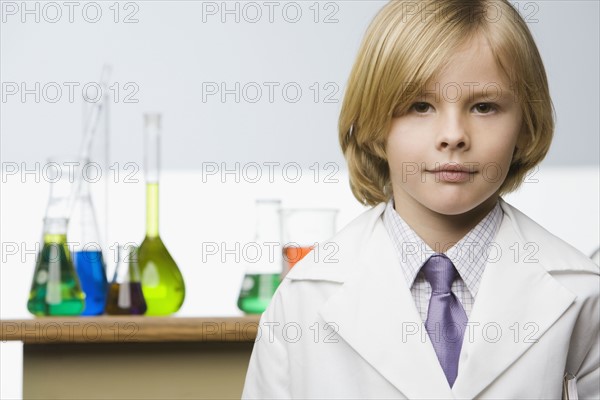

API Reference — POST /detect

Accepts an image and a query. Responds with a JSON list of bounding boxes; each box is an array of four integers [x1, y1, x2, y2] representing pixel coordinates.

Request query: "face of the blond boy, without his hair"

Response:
[[386, 37, 522, 215]]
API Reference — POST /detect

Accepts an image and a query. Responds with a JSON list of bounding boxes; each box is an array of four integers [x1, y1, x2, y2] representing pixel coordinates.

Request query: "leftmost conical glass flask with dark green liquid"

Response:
[[27, 218, 85, 316]]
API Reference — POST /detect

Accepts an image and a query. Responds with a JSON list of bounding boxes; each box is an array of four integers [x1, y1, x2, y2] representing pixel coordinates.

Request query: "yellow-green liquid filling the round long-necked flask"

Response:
[[138, 182, 185, 316]]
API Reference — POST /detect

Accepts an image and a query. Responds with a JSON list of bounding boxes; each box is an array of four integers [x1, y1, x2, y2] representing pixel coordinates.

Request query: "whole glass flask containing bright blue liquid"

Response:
[[69, 176, 108, 315]]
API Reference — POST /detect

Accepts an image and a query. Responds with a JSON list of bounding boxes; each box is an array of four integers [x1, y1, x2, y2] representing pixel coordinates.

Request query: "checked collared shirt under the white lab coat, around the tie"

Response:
[[382, 200, 504, 322]]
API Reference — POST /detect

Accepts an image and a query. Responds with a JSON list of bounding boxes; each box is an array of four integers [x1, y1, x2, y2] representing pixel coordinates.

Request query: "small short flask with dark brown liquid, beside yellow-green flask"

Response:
[[106, 245, 147, 315]]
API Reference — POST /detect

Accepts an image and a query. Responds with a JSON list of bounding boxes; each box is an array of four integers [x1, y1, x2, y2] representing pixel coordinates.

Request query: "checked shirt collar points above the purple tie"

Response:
[[383, 199, 504, 297]]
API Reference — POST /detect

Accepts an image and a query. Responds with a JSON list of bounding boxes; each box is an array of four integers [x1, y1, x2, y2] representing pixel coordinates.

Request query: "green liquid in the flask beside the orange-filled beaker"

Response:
[[238, 274, 281, 314]]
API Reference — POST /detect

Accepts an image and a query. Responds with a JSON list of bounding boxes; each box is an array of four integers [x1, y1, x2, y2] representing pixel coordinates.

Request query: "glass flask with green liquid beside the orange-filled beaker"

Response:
[[237, 200, 281, 314]]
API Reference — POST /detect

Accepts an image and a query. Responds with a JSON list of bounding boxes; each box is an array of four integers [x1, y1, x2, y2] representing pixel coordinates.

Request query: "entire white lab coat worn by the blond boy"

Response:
[[242, 200, 600, 399]]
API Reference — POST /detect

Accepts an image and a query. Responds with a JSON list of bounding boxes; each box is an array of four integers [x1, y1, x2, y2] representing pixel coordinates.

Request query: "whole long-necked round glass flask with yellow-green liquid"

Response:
[[139, 114, 185, 315]]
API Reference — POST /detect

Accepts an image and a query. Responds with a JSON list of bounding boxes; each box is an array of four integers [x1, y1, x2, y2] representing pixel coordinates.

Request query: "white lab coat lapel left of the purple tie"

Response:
[[320, 218, 453, 399]]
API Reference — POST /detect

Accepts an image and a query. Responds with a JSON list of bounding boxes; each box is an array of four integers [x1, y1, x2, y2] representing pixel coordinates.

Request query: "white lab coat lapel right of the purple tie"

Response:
[[452, 202, 575, 398]]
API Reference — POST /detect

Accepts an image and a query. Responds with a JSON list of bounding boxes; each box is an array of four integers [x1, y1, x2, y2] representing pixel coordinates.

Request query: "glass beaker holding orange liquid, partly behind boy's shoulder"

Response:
[[281, 208, 338, 276]]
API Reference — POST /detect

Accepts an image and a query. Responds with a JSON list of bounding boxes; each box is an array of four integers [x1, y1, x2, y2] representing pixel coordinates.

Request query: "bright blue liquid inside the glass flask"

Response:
[[75, 251, 108, 315]]
